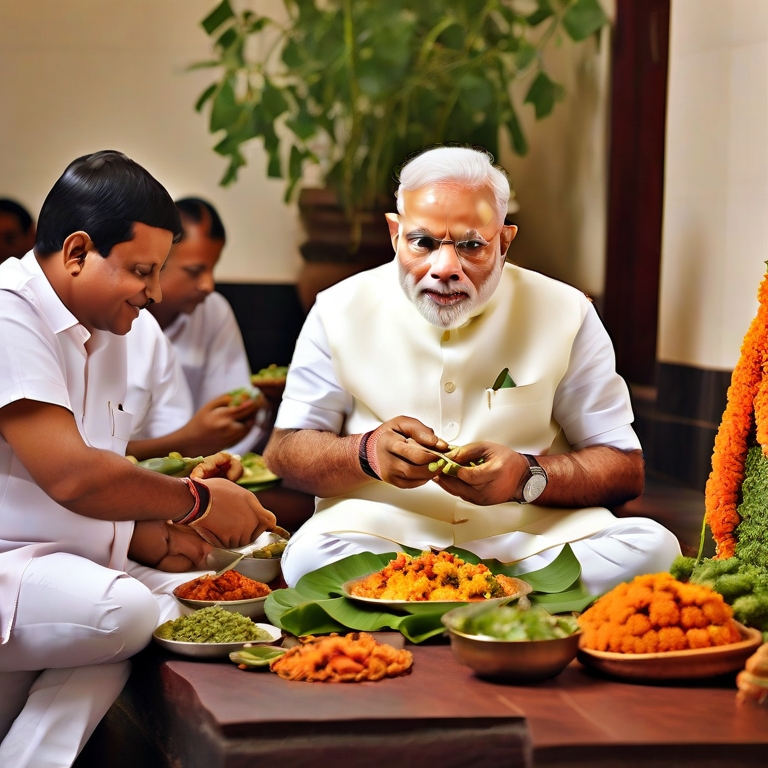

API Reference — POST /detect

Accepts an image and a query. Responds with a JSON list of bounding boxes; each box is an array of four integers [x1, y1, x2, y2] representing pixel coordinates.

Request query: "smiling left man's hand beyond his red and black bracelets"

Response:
[[190, 478, 277, 549]]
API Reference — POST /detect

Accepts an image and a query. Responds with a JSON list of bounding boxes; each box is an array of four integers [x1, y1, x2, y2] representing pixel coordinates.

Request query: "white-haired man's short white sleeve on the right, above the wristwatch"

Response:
[[553, 304, 640, 451]]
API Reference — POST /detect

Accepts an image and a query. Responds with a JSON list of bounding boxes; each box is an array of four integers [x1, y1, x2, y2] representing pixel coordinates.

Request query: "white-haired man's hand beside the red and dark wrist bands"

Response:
[[368, 416, 449, 488]]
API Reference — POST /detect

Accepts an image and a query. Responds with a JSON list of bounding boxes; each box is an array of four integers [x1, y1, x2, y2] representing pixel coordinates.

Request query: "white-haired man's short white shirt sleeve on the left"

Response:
[[275, 306, 352, 434]]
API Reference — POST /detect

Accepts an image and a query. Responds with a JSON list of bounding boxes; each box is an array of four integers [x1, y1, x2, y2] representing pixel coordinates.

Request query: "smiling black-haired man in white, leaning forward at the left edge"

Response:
[[0, 151, 275, 768]]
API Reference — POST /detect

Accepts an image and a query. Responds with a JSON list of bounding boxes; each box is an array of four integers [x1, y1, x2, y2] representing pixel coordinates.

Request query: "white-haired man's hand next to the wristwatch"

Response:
[[435, 442, 528, 506]]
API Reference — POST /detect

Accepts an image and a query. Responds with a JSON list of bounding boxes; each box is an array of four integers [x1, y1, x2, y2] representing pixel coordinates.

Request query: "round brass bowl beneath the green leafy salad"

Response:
[[448, 627, 581, 683]]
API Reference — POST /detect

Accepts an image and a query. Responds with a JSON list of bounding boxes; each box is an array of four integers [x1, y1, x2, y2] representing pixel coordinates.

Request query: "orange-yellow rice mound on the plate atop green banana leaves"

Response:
[[349, 552, 527, 602]]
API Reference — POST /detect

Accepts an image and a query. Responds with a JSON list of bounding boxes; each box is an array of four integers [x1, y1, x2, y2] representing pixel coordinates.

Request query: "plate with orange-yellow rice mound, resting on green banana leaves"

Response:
[[341, 552, 531, 613]]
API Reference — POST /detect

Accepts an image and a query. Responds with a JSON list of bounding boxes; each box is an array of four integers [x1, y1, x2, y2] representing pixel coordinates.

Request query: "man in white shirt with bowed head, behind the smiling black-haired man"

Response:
[[150, 198, 267, 453]]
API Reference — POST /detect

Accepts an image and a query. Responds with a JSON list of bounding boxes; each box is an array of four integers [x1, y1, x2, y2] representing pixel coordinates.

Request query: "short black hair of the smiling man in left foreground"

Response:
[[35, 150, 182, 258]]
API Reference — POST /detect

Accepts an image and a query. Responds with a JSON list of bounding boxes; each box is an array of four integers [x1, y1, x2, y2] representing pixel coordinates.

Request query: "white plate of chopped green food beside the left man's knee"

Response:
[[152, 605, 282, 659]]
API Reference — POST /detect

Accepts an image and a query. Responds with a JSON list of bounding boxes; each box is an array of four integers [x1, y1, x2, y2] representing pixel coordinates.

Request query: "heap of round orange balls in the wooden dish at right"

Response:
[[579, 573, 741, 653]]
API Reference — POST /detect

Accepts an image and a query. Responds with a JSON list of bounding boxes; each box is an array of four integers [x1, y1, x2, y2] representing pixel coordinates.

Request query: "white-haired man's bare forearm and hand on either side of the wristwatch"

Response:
[[437, 443, 645, 507]]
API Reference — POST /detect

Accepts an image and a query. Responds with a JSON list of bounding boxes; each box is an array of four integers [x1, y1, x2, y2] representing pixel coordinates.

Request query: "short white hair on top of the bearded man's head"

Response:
[[397, 147, 509, 220]]
